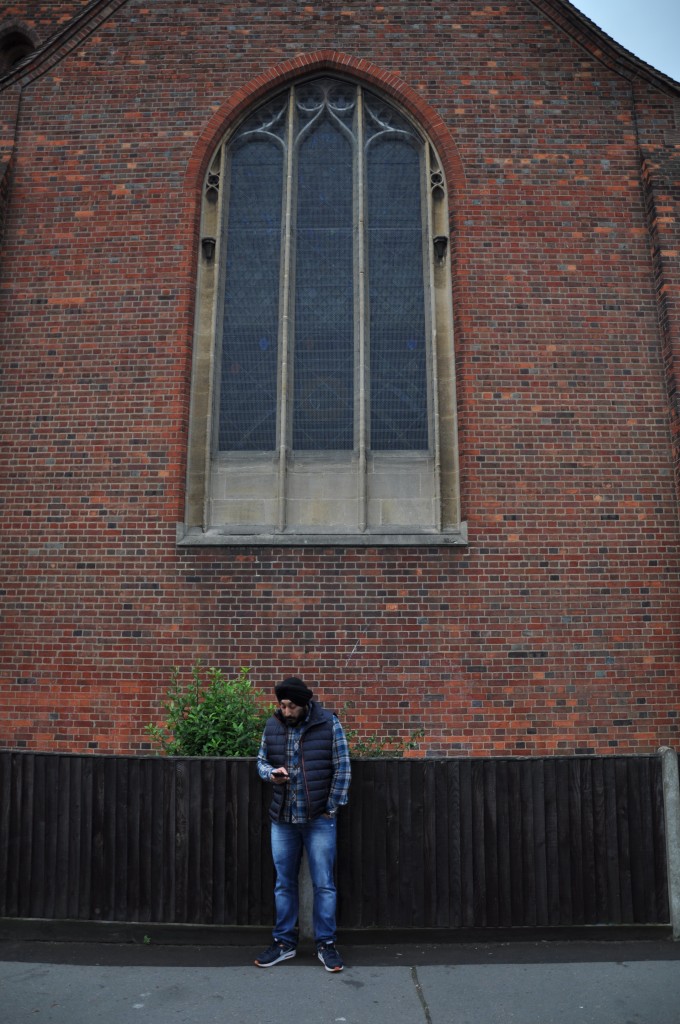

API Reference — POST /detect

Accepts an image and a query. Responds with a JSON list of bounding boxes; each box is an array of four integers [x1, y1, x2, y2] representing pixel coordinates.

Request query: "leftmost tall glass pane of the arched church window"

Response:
[[219, 130, 284, 452]]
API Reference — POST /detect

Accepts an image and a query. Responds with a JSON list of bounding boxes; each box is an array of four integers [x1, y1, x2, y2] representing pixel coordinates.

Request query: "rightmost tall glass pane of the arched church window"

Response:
[[367, 131, 428, 451]]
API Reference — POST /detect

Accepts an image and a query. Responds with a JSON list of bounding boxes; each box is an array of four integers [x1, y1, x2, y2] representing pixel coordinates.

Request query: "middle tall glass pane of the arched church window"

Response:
[[293, 89, 354, 451]]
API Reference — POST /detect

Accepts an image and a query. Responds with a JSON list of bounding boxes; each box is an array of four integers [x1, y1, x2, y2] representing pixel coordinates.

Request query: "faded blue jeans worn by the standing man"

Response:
[[271, 817, 337, 946]]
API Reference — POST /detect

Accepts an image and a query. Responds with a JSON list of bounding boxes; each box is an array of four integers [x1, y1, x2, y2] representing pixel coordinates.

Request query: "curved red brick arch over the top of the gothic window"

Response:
[[185, 50, 465, 201]]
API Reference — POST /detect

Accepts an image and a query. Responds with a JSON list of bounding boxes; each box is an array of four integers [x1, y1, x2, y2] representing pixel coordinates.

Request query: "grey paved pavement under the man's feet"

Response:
[[0, 938, 680, 1024]]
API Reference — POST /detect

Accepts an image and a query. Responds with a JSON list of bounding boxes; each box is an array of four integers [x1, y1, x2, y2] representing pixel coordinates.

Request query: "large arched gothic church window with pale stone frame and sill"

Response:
[[181, 78, 463, 544]]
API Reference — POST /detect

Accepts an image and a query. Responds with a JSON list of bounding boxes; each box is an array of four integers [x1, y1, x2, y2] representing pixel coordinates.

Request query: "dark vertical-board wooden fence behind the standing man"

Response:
[[0, 751, 670, 930]]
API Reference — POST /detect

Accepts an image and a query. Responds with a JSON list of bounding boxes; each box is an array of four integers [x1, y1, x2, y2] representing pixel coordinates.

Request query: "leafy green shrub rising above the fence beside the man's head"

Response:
[[146, 662, 274, 758]]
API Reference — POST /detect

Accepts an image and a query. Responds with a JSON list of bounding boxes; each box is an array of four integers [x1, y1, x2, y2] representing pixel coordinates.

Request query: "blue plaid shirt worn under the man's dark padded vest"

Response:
[[257, 703, 351, 823]]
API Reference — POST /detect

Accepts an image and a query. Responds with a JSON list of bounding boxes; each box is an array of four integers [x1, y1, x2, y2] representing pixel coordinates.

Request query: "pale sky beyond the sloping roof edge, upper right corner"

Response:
[[571, 0, 680, 82]]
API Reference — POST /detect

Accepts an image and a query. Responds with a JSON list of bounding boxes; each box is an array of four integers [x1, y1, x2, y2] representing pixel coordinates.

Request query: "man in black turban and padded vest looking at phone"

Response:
[[255, 676, 350, 972]]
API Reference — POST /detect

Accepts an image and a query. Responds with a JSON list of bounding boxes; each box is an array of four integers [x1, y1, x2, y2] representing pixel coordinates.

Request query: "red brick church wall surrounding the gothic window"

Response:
[[0, 0, 679, 755]]
